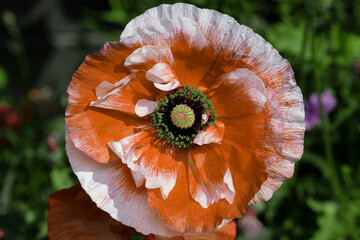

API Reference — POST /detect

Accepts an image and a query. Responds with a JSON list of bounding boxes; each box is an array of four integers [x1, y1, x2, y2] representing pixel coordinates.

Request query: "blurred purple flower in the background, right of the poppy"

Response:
[[304, 90, 337, 130]]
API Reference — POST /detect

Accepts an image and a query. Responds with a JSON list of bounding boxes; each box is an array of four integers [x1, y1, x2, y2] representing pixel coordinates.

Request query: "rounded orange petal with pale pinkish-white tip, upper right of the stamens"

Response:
[[206, 68, 266, 118]]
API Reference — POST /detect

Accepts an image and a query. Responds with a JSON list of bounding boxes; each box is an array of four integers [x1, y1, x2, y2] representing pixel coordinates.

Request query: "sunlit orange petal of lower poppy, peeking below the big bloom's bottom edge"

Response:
[[145, 221, 236, 240]]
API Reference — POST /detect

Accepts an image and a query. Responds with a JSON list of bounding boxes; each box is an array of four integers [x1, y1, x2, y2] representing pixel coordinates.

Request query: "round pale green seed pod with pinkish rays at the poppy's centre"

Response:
[[170, 104, 195, 128]]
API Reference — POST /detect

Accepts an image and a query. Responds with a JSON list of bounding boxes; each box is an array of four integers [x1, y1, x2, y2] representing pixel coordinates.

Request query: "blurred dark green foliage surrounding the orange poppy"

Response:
[[0, 0, 360, 240]]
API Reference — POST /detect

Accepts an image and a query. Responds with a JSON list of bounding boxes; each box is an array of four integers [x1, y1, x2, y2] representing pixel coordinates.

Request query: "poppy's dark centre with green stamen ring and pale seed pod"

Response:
[[151, 85, 217, 148]]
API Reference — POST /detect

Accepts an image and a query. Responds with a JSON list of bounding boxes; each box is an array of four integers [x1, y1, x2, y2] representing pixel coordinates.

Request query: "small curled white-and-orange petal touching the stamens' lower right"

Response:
[[193, 120, 225, 145]]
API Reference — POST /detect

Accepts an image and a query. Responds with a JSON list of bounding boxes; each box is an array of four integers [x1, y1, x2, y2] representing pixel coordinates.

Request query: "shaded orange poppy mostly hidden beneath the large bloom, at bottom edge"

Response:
[[47, 184, 236, 240]]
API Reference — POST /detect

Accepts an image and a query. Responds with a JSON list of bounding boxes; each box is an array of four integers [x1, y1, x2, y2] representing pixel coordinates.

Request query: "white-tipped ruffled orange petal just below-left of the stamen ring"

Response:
[[109, 131, 177, 198]]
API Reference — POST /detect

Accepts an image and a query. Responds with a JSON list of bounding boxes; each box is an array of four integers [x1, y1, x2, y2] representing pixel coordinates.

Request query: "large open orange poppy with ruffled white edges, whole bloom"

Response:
[[65, 4, 305, 237]]
